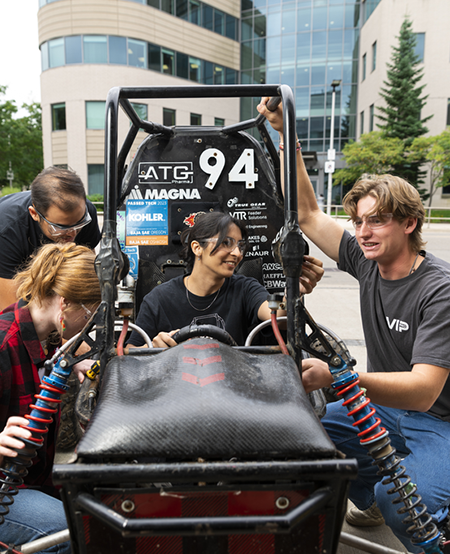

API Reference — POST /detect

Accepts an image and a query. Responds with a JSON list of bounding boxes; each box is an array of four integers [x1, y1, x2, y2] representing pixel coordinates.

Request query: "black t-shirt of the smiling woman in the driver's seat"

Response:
[[129, 275, 269, 346]]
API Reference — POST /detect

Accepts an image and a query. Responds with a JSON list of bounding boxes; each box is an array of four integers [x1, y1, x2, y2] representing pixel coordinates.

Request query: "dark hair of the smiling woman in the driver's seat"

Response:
[[180, 212, 248, 272]]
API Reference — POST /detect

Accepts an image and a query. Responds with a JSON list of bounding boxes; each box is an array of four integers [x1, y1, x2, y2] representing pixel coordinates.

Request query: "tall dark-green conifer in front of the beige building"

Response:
[[377, 18, 432, 195]]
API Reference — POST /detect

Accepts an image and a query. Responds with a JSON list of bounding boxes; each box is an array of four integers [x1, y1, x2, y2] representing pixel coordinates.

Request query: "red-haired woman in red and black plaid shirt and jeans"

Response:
[[0, 243, 101, 554]]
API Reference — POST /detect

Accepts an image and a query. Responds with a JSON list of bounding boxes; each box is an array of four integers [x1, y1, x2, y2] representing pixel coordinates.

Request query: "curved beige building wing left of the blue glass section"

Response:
[[38, 0, 240, 194]]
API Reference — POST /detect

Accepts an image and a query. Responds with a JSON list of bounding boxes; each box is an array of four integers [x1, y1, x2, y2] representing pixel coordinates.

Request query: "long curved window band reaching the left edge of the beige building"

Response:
[[41, 35, 238, 85]]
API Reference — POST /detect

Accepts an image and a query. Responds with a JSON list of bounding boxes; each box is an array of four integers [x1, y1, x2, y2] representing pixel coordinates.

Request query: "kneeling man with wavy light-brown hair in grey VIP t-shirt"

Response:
[[258, 99, 450, 552]]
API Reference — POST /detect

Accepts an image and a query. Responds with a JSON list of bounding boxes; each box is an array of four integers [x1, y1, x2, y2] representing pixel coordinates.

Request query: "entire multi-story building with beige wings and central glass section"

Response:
[[39, 0, 450, 205]]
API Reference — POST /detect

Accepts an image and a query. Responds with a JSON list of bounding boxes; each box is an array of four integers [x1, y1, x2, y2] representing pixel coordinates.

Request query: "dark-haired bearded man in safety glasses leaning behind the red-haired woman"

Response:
[[0, 167, 101, 310]]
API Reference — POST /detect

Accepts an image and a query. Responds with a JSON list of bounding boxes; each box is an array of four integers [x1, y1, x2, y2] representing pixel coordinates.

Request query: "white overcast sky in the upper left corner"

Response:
[[0, 0, 41, 115]]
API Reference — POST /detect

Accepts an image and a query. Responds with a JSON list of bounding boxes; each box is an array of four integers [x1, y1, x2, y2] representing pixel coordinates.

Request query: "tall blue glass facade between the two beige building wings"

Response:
[[241, 0, 361, 152]]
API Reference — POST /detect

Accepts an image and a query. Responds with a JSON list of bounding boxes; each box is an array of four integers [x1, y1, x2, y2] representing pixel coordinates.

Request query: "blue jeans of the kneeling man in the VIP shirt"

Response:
[[322, 402, 450, 552]]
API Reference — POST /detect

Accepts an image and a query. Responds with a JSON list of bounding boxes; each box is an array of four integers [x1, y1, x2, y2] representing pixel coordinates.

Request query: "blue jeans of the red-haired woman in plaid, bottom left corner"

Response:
[[0, 489, 72, 554]]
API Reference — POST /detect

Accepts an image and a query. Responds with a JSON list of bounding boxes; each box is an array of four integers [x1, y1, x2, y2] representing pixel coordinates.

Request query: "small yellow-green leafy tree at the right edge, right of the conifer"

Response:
[[407, 129, 450, 206]]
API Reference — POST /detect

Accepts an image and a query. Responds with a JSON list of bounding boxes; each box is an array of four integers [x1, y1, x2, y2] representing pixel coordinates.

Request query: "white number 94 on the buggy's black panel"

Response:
[[199, 148, 258, 189]]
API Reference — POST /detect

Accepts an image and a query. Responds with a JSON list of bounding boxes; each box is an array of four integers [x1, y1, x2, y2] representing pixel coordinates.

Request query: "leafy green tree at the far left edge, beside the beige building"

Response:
[[0, 86, 44, 188]]
